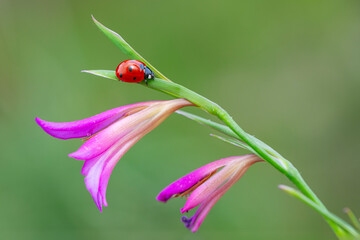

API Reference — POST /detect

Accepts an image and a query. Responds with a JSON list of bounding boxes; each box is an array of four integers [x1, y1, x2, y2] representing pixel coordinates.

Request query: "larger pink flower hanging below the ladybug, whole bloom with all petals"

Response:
[[35, 99, 193, 212]]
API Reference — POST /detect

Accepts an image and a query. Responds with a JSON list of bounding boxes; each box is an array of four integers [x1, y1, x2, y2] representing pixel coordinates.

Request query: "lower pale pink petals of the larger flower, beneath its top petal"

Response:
[[81, 100, 194, 211]]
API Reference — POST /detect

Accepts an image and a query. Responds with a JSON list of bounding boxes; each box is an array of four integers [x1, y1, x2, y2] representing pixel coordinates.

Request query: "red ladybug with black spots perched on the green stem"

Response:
[[115, 60, 154, 83]]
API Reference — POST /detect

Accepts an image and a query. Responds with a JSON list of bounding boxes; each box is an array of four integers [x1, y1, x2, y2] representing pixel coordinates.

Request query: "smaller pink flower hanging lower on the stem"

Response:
[[156, 154, 262, 232]]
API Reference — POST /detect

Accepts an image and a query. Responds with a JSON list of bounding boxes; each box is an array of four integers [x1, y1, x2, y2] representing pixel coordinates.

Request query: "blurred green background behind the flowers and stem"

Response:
[[0, 0, 360, 240]]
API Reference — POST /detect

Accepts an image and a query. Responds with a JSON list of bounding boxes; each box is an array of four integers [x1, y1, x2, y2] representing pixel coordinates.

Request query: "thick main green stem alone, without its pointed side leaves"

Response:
[[144, 79, 359, 238]]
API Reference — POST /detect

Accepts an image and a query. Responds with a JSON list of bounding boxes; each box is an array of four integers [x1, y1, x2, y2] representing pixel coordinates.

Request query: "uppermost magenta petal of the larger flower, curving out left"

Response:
[[35, 101, 154, 139]]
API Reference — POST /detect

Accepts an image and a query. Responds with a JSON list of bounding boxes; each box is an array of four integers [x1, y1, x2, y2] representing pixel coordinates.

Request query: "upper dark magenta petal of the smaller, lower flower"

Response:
[[156, 157, 238, 202]]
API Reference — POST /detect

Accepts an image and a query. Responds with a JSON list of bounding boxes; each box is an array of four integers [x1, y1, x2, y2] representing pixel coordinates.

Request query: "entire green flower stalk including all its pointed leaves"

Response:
[[84, 16, 360, 239]]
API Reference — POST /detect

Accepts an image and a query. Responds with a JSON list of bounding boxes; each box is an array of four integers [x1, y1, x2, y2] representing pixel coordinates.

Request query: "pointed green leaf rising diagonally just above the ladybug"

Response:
[[91, 16, 170, 81]]
